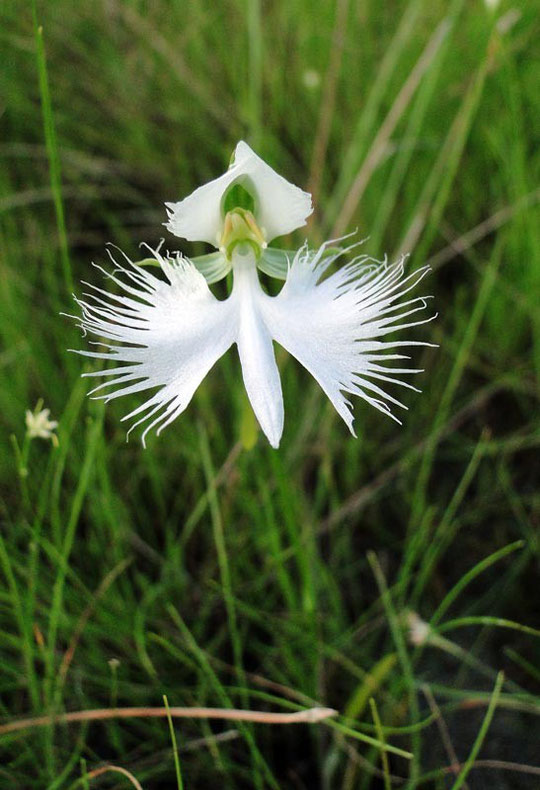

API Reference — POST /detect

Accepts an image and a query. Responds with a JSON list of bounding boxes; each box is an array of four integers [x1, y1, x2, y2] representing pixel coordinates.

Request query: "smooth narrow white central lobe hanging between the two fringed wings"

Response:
[[231, 253, 283, 448]]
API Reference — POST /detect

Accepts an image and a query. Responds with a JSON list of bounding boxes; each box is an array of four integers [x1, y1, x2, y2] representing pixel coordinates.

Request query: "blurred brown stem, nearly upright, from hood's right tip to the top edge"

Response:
[[308, 0, 349, 206]]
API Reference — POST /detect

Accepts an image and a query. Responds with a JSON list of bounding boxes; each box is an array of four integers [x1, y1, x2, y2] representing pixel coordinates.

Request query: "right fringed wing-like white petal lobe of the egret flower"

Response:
[[262, 246, 434, 435]]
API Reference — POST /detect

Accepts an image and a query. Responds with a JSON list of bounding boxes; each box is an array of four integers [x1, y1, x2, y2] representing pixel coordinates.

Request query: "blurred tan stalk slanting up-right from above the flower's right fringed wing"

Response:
[[330, 19, 450, 238]]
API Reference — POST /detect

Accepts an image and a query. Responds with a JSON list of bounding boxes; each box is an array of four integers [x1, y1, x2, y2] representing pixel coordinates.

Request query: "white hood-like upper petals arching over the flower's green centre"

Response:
[[165, 141, 313, 246]]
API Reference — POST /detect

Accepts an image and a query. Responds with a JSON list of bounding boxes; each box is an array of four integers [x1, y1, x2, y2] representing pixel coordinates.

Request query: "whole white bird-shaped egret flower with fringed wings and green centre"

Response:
[[71, 142, 431, 448]]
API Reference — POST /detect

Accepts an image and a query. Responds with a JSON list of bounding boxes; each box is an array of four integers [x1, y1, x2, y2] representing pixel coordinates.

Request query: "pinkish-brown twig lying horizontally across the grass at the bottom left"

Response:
[[0, 707, 337, 735]]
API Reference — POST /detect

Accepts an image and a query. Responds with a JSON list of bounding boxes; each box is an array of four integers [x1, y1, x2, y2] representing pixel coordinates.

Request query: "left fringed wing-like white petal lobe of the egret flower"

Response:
[[71, 252, 237, 444]]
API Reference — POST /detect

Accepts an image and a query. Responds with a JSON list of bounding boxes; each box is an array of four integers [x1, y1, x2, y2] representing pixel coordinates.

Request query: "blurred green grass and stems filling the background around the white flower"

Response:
[[0, 0, 540, 790]]
